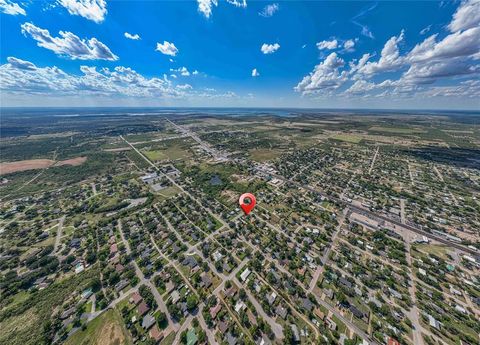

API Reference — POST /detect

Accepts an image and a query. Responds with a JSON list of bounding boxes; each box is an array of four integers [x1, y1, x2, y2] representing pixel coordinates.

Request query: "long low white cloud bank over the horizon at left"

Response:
[[0, 57, 189, 98]]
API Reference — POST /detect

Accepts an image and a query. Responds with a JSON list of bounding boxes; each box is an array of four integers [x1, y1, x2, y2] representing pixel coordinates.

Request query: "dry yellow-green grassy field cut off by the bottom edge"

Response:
[[65, 309, 133, 345]]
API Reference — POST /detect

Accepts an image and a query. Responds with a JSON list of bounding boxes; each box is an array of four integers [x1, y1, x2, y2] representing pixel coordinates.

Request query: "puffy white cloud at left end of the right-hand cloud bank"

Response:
[[294, 53, 348, 95]]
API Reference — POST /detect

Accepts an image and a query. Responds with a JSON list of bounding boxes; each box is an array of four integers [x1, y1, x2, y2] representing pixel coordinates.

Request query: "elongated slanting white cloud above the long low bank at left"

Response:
[[21, 23, 118, 61]]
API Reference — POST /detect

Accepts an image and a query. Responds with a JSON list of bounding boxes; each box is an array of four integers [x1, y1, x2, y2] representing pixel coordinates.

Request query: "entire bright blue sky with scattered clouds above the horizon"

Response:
[[0, 0, 480, 109]]
